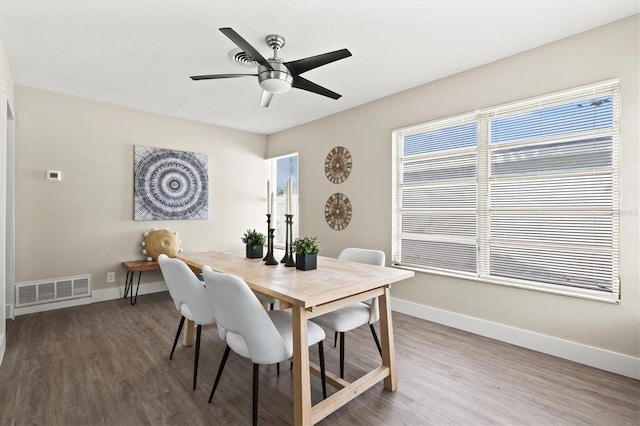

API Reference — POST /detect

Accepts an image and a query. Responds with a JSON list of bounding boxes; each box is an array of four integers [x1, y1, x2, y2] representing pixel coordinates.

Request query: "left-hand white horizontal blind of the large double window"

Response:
[[394, 114, 478, 275]]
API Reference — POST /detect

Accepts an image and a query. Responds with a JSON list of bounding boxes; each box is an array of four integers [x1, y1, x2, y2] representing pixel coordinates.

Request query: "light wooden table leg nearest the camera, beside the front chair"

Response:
[[293, 306, 311, 425]]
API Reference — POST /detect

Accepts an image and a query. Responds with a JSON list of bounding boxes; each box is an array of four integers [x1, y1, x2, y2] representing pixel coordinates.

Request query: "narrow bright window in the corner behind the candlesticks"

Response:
[[267, 154, 299, 248]]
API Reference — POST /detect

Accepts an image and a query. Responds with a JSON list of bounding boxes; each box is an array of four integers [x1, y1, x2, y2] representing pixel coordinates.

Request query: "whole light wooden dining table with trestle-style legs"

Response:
[[177, 251, 414, 425]]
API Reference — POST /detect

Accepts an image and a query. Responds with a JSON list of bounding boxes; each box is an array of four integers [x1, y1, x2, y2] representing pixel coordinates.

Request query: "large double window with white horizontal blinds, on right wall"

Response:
[[393, 81, 619, 301]]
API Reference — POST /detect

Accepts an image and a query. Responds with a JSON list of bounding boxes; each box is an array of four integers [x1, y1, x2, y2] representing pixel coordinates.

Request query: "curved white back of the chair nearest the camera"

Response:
[[202, 266, 291, 364]]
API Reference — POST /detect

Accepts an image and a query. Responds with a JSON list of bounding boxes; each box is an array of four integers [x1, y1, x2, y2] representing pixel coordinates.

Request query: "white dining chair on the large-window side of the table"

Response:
[[313, 247, 385, 378]]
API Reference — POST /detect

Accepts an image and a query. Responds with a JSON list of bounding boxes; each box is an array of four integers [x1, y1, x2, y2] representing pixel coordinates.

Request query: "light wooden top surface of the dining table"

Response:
[[176, 251, 414, 308]]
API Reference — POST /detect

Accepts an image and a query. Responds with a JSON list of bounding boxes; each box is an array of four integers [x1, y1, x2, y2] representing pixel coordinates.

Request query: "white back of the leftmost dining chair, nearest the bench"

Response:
[[158, 254, 215, 324]]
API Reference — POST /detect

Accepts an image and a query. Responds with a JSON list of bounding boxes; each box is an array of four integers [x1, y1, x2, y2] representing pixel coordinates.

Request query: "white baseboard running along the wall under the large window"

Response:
[[391, 298, 640, 379]]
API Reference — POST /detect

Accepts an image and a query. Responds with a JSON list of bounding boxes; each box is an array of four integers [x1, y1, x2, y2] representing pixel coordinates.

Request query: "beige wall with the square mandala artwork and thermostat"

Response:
[[15, 85, 266, 290]]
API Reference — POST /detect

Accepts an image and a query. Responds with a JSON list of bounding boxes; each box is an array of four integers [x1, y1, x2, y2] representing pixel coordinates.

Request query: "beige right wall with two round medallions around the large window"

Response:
[[268, 15, 640, 357]]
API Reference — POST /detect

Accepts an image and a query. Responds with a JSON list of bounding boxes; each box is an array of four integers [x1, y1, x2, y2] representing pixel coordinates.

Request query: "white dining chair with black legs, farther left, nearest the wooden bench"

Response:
[[158, 254, 215, 390]]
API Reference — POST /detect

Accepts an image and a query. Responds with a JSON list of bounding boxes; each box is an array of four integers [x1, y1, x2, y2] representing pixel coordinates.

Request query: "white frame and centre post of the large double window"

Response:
[[392, 79, 621, 303]]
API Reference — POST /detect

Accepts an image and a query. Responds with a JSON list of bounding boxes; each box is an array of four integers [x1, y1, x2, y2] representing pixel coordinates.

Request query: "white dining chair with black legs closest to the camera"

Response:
[[202, 266, 327, 425]]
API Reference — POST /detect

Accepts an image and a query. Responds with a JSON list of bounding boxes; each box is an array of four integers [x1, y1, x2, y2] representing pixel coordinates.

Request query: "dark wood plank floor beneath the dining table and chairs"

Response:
[[0, 293, 640, 426]]
